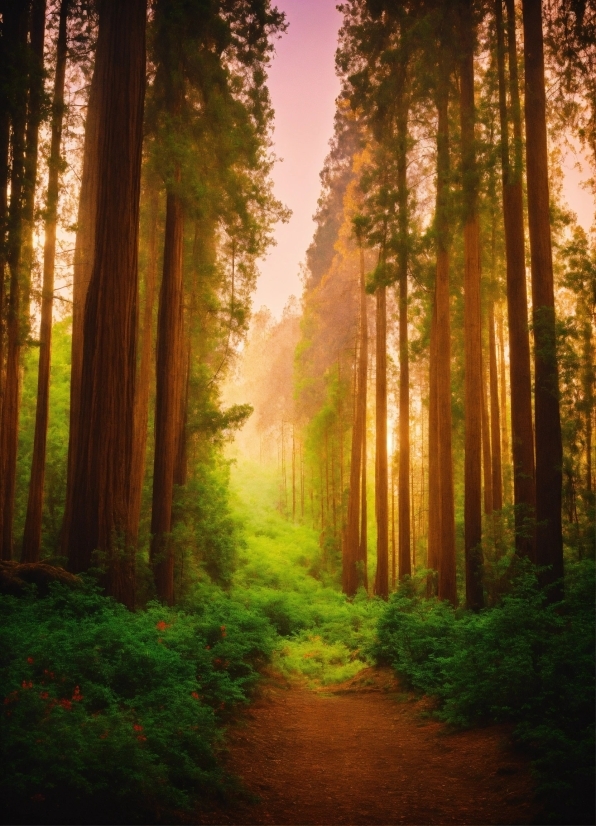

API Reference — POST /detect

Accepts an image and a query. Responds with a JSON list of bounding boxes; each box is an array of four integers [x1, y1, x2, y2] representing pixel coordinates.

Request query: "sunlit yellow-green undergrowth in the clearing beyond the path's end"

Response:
[[226, 462, 384, 685]]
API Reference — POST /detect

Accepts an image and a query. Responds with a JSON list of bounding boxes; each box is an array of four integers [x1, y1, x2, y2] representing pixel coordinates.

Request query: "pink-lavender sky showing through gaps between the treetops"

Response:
[[254, 0, 594, 318]]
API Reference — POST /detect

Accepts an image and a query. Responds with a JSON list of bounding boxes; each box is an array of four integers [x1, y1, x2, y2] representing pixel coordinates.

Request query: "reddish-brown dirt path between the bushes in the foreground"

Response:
[[199, 669, 536, 824]]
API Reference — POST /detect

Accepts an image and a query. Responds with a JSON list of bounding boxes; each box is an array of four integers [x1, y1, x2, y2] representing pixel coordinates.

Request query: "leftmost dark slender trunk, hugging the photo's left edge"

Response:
[[0, 3, 29, 559]]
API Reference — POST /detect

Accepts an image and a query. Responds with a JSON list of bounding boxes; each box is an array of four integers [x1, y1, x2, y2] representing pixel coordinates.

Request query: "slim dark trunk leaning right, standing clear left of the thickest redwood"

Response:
[[22, 0, 69, 562]]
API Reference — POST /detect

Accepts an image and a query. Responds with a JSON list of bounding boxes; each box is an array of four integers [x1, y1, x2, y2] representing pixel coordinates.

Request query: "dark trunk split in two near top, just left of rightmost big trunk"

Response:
[[495, 0, 536, 559]]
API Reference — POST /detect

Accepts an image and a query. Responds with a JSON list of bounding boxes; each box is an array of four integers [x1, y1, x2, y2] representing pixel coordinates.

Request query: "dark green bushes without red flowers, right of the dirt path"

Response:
[[374, 561, 594, 823]]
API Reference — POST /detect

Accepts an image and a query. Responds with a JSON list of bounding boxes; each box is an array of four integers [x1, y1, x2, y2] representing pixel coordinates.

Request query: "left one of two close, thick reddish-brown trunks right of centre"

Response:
[[429, 54, 457, 605]]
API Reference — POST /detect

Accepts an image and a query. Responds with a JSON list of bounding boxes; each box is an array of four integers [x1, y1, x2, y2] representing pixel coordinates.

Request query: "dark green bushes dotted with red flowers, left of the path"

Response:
[[0, 586, 272, 823]]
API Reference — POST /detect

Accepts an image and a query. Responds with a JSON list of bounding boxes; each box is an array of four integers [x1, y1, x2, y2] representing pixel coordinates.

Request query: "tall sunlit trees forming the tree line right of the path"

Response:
[[241, 0, 596, 609]]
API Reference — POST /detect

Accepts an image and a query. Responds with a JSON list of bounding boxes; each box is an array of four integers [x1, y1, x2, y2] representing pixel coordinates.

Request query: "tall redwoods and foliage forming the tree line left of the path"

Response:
[[0, 0, 286, 607]]
